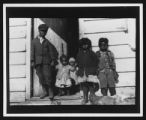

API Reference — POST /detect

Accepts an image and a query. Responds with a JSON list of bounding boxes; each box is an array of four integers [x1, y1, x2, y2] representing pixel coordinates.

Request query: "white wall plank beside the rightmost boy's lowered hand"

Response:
[[116, 72, 136, 87]]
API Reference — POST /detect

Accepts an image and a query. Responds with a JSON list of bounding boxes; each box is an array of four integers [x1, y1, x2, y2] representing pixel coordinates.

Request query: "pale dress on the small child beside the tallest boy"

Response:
[[55, 64, 71, 88]]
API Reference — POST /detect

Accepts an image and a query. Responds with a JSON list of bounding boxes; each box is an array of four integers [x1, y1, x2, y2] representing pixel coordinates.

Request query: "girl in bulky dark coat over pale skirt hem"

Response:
[[76, 38, 99, 105]]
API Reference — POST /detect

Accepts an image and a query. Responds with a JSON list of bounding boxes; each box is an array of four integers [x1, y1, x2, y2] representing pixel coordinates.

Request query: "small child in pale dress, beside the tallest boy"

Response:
[[55, 55, 71, 95]]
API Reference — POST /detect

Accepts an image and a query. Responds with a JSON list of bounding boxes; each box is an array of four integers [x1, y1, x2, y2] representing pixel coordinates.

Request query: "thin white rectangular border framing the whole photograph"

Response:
[[3, 3, 143, 117]]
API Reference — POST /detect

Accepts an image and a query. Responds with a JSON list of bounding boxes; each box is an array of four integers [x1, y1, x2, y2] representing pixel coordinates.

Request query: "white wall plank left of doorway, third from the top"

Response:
[[9, 39, 26, 52]]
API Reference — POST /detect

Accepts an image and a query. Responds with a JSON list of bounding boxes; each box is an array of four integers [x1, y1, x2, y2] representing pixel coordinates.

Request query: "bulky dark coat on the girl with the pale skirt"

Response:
[[76, 50, 98, 77]]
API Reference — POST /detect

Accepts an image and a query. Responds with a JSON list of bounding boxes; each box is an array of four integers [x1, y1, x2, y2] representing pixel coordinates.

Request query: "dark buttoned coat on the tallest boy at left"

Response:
[[31, 37, 58, 65]]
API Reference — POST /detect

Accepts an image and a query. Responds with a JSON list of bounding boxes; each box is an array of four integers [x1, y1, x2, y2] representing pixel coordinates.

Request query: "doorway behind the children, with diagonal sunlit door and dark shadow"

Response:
[[31, 18, 79, 97]]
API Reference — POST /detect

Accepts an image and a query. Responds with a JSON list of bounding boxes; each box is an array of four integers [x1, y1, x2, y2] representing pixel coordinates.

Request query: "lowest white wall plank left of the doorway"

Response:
[[10, 92, 25, 102]]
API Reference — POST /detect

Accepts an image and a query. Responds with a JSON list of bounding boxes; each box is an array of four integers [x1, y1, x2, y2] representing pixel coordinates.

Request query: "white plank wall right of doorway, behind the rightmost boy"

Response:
[[79, 18, 136, 96]]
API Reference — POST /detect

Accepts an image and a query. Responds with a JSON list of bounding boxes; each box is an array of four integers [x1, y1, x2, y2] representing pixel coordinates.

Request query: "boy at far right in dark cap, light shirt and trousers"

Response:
[[96, 38, 118, 96]]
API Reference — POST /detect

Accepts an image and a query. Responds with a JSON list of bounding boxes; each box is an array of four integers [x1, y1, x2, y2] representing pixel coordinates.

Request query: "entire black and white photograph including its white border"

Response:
[[3, 4, 143, 116]]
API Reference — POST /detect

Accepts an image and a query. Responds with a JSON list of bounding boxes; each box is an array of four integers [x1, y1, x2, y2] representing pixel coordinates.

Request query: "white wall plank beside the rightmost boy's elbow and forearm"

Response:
[[116, 58, 136, 72]]
